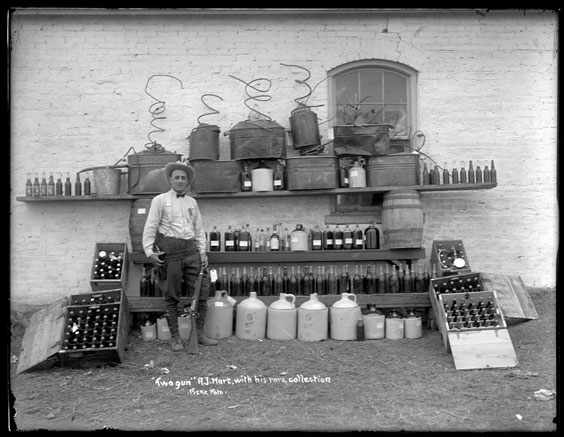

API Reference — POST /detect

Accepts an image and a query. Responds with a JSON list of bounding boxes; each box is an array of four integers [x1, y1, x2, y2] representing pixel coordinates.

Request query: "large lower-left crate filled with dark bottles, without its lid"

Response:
[[59, 290, 130, 367]]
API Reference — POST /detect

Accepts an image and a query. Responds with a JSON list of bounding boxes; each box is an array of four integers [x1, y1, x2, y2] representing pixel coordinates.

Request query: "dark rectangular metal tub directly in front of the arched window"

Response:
[[333, 124, 391, 156]]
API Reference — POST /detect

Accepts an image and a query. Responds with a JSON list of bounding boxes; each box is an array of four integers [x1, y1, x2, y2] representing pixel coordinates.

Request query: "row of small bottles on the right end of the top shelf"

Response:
[[421, 160, 497, 185]]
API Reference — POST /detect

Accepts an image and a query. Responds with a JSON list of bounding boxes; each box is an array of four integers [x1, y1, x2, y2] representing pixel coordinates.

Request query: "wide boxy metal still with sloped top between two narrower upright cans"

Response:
[[225, 120, 286, 160]]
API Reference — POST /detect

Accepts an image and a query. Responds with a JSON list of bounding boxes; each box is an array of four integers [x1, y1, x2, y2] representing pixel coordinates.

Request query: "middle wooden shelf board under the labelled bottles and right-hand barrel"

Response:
[[129, 248, 425, 266]]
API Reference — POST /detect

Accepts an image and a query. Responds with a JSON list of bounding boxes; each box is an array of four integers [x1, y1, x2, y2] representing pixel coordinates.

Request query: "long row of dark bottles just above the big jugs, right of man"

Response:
[[209, 264, 436, 296]]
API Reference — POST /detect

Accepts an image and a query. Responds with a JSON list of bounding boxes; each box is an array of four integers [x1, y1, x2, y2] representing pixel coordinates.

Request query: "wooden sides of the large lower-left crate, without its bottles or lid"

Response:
[[59, 297, 131, 367]]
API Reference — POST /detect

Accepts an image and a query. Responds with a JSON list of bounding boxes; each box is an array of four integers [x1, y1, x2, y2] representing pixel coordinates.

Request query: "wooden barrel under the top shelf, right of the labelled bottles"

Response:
[[382, 190, 423, 249]]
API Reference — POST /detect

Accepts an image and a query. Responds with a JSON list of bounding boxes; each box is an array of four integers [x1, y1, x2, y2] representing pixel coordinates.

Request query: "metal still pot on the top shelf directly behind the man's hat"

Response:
[[127, 149, 182, 194]]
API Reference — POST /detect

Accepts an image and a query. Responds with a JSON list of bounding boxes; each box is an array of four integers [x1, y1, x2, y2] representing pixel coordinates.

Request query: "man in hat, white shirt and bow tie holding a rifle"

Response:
[[143, 162, 217, 351]]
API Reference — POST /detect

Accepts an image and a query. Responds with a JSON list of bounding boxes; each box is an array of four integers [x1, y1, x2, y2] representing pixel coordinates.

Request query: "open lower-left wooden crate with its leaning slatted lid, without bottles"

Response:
[[17, 289, 131, 373]]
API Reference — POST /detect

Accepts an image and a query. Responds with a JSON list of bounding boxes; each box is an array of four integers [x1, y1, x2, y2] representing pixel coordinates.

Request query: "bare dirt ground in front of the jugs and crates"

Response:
[[9, 290, 560, 432]]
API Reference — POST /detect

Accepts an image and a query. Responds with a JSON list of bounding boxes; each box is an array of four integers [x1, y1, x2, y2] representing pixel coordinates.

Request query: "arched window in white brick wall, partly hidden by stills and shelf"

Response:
[[326, 60, 417, 223]]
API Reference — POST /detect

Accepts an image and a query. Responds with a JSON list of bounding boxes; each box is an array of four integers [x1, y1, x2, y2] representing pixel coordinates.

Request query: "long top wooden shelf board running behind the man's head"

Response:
[[16, 184, 497, 202]]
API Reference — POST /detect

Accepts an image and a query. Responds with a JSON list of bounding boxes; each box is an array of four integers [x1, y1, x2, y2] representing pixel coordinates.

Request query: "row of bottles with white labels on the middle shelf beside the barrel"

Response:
[[208, 223, 380, 252]]
